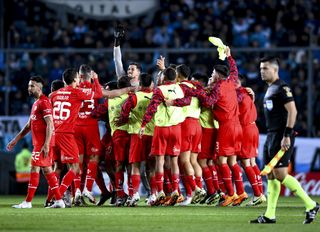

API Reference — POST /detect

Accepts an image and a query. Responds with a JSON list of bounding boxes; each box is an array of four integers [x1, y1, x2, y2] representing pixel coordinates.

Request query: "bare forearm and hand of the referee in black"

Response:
[[281, 101, 297, 151]]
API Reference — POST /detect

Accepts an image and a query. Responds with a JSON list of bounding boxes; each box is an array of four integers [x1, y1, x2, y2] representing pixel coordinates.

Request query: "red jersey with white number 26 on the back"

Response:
[[50, 86, 102, 133]]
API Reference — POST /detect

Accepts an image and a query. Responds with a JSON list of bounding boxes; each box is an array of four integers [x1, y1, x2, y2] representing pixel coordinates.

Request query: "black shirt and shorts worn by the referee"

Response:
[[263, 79, 294, 168]]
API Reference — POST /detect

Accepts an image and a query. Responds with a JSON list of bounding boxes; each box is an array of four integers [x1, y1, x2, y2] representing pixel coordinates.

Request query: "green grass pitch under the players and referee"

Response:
[[0, 196, 320, 232]]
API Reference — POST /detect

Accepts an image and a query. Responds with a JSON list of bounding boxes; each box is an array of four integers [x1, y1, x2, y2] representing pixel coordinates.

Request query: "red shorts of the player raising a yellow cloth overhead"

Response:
[[216, 122, 242, 156]]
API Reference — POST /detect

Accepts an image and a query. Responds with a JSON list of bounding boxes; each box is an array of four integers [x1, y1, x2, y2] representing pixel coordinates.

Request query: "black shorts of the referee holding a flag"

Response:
[[263, 131, 294, 168]]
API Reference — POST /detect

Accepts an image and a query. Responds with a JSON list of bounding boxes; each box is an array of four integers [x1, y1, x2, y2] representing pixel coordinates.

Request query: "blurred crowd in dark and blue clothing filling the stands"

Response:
[[0, 0, 320, 136]]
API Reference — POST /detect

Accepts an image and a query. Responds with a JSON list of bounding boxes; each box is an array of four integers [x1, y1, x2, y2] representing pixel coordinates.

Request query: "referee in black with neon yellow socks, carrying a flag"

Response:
[[250, 57, 320, 224]]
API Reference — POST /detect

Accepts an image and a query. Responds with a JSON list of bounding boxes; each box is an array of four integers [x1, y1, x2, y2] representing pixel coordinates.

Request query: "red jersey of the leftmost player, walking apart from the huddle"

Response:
[[30, 95, 53, 147]]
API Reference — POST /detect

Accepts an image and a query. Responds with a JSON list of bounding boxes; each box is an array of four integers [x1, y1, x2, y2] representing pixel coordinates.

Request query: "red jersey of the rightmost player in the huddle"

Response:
[[238, 87, 257, 125]]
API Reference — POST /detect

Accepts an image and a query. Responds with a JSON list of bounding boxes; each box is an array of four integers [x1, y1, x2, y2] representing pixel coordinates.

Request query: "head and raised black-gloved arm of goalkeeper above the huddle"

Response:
[[113, 25, 141, 86]]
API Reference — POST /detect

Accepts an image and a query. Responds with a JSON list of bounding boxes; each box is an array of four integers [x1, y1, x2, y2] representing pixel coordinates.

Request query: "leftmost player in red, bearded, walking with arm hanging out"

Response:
[[7, 76, 65, 208]]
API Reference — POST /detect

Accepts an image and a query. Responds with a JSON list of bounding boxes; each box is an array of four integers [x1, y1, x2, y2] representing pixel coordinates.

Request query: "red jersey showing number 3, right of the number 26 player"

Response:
[[76, 81, 100, 126]]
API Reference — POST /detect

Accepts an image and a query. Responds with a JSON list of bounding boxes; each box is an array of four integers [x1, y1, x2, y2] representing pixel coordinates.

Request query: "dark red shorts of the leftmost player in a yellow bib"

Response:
[[112, 130, 130, 162]]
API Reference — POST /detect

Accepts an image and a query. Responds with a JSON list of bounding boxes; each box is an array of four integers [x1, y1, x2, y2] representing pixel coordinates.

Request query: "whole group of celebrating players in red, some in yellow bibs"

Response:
[[7, 26, 266, 208]]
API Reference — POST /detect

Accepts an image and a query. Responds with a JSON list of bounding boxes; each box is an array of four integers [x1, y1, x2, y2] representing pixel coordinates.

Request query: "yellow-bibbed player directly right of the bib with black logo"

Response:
[[167, 64, 206, 205]]
